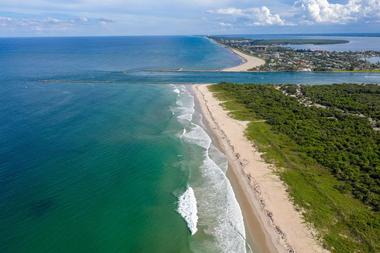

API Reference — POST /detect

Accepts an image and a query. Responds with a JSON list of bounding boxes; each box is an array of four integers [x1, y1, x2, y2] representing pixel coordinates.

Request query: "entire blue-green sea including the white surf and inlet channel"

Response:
[[0, 36, 380, 253]]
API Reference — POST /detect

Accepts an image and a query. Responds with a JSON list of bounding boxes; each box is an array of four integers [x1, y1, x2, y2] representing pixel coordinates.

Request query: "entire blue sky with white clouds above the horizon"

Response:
[[0, 0, 380, 37]]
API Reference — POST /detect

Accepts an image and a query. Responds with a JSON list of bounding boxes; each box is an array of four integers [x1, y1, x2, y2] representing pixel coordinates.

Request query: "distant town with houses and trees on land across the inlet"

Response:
[[209, 37, 380, 72]]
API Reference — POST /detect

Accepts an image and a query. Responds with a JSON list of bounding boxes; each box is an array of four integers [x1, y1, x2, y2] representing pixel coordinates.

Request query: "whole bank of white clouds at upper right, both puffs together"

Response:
[[209, 0, 380, 26]]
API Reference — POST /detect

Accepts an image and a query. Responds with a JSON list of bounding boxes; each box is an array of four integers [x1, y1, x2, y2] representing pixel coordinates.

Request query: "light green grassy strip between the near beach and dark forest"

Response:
[[210, 85, 380, 253]]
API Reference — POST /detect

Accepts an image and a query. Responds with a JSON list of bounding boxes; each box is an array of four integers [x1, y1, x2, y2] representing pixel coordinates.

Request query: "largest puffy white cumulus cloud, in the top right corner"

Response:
[[296, 0, 380, 24]]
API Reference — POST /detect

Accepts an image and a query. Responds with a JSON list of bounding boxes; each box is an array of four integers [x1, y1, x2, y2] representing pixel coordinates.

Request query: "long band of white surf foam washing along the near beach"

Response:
[[176, 86, 246, 253]]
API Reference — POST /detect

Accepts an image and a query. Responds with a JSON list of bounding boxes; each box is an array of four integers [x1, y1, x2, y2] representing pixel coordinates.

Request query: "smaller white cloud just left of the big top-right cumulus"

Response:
[[209, 6, 285, 26]]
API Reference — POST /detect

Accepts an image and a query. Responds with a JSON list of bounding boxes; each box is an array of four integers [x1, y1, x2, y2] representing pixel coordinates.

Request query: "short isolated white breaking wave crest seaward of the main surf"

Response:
[[178, 186, 198, 235]]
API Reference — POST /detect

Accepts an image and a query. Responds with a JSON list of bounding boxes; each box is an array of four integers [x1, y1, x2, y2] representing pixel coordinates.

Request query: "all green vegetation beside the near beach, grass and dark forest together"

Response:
[[210, 83, 380, 252]]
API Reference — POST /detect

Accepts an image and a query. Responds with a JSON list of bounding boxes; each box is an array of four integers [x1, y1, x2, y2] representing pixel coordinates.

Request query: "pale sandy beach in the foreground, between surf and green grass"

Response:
[[193, 85, 329, 253]]
